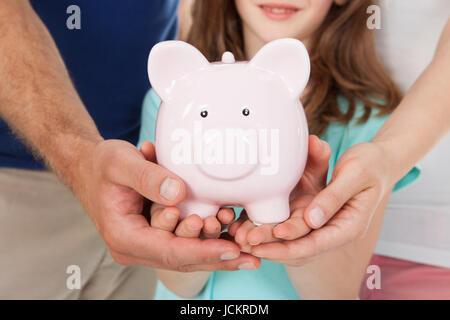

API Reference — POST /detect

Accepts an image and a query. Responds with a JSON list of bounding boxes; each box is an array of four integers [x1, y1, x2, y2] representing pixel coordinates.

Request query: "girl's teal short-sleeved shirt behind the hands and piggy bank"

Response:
[[138, 90, 420, 300]]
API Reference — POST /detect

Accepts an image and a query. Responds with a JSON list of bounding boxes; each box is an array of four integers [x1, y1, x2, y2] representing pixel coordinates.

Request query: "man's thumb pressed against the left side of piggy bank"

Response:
[[105, 142, 186, 206]]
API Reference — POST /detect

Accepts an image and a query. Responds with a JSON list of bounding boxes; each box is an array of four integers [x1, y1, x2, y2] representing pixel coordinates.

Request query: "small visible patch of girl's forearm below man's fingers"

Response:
[[156, 269, 211, 299]]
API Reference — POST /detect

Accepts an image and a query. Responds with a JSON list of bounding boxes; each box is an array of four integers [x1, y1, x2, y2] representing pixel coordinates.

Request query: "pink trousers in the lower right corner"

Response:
[[360, 255, 450, 300]]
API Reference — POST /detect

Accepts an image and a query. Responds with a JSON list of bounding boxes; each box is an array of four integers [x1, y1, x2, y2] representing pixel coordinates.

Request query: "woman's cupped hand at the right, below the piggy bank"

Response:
[[252, 143, 392, 261]]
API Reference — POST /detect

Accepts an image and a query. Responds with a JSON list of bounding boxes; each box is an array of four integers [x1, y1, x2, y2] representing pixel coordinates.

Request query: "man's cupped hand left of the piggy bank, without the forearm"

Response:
[[74, 140, 255, 271]]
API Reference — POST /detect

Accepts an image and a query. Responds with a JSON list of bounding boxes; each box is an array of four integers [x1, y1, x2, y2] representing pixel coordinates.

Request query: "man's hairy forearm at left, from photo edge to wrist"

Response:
[[0, 0, 102, 185]]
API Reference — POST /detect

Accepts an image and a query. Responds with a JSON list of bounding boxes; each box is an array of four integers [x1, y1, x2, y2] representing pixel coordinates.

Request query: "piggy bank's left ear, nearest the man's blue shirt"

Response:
[[148, 41, 209, 100]]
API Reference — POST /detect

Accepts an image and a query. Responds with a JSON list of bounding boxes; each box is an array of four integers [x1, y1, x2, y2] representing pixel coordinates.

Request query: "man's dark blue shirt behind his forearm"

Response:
[[0, 0, 178, 169]]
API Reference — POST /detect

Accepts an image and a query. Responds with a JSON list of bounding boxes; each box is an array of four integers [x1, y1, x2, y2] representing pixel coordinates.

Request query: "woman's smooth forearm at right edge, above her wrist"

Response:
[[373, 22, 450, 183]]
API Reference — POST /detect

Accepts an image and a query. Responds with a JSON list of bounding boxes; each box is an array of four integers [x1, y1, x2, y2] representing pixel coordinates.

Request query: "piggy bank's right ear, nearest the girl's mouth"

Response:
[[249, 39, 310, 97]]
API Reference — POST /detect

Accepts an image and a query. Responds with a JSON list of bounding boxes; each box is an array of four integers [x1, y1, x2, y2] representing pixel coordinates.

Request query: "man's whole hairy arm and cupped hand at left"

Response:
[[0, 0, 255, 271]]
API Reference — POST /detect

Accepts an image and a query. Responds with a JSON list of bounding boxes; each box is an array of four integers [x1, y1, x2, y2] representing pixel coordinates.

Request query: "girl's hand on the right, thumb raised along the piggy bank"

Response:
[[229, 136, 331, 264]]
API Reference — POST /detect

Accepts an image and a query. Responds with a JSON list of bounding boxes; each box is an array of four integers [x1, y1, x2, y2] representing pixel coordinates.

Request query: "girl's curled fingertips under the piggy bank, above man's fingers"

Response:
[[150, 203, 234, 239]]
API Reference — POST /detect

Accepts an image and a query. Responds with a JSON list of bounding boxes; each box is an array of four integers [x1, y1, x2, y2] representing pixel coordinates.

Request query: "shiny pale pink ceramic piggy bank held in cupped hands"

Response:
[[148, 39, 310, 224]]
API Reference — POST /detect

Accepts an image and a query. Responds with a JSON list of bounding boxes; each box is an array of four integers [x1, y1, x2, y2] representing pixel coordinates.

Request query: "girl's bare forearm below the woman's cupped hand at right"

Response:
[[286, 192, 390, 300]]
